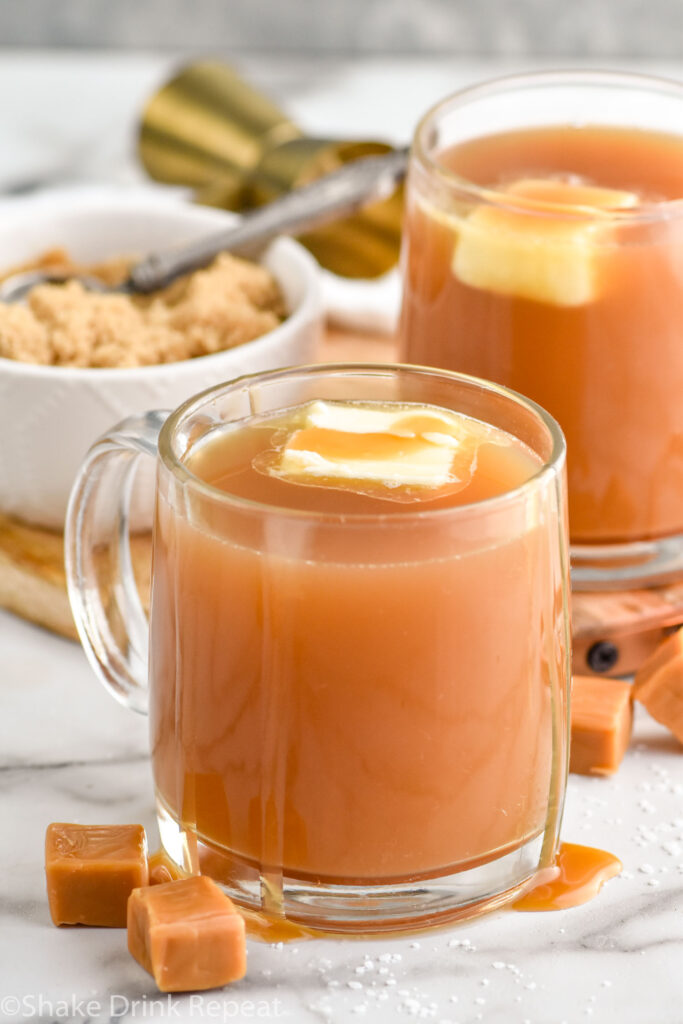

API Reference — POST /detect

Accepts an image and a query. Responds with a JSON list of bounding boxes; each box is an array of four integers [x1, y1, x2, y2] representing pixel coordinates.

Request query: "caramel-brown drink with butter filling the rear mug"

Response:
[[401, 126, 683, 543]]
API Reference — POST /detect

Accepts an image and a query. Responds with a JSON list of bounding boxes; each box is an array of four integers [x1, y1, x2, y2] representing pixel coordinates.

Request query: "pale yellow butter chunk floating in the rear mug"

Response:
[[453, 178, 638, 306]]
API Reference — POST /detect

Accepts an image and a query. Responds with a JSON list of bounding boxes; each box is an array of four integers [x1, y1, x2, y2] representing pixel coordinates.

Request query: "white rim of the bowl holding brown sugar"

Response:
[[0, 186, 323, 382]]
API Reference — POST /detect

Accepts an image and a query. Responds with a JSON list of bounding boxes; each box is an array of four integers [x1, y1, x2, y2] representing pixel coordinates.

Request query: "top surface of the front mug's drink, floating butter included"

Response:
[[187, 401, 541, 515]]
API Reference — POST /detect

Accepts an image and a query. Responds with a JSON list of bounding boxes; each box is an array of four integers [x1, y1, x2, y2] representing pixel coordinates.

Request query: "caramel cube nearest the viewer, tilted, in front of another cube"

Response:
[[128, 874, 247, 992]]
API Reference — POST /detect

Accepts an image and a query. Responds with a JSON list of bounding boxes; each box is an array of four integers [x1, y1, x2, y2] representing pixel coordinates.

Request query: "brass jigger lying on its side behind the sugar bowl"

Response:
[[138, 60, 402, 278]]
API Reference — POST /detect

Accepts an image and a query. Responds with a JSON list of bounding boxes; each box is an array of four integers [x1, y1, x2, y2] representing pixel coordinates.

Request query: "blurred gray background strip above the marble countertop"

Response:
[[0, 0, 683, 59]]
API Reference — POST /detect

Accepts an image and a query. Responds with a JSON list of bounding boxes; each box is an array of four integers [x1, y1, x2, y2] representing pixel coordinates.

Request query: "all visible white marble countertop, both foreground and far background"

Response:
[[0, 54, 683, 1024]]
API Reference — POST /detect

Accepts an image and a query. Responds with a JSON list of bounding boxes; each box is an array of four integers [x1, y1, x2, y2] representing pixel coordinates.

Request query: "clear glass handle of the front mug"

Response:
[[65, 410, 169, 714]]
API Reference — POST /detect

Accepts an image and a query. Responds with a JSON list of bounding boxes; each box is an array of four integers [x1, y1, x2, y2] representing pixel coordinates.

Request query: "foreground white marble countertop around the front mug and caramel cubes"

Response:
[[0, 613, 683, 1024]]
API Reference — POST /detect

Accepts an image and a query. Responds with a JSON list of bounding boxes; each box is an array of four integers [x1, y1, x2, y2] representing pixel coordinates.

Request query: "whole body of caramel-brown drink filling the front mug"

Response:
[[151, 395, 566, 884]]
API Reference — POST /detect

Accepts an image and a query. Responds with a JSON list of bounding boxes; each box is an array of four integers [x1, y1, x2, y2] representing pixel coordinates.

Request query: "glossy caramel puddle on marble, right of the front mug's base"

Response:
[[512, 843, 623, 910]]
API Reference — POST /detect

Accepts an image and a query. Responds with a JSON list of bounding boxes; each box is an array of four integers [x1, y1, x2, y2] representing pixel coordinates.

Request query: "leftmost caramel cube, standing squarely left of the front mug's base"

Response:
[[45, 821, 148, 928]]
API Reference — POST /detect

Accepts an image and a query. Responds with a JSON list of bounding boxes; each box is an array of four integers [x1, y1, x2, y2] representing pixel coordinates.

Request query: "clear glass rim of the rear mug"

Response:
[[411, 69, 683, 223]]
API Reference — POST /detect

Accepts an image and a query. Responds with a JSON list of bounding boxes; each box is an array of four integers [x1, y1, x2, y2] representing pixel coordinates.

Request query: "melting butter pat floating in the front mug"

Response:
[[276, 401, 486, 488]]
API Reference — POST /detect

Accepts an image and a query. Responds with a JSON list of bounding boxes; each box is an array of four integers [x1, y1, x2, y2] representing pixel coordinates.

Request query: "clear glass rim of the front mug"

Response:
[[158, 362, 566, 525]]
